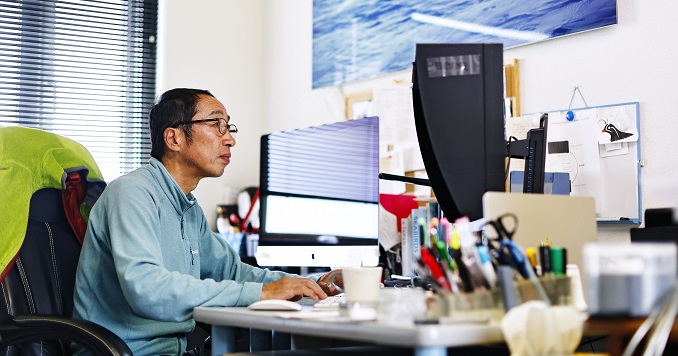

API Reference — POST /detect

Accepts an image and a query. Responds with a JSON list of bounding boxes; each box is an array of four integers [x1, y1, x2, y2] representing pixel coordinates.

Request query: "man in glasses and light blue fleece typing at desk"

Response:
[[74, 89, 346, 355]]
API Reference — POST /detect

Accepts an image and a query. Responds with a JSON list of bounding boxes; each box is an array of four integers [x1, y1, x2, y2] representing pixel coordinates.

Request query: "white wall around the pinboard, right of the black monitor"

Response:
[[504, 0, 678, 241]]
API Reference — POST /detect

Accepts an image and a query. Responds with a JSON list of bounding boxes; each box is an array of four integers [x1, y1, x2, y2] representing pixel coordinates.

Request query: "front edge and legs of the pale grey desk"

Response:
[[193, 307, 503, 355]]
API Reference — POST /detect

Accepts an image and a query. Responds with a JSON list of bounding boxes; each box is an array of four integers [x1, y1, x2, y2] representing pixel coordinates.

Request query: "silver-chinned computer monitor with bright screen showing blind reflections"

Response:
[[255, 117, 379, 267]]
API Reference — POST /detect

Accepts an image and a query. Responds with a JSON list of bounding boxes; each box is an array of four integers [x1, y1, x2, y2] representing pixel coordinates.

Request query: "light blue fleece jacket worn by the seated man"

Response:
[[74, 158, 294, 356]]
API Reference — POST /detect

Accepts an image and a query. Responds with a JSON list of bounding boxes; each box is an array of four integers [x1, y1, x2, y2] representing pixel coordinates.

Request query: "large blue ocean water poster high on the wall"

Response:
[[313, 0, 617, 88]]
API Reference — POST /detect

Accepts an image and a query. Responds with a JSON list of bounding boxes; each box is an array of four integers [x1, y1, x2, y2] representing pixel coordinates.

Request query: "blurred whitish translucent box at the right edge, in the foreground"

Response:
[[584, 243, 677, 316]]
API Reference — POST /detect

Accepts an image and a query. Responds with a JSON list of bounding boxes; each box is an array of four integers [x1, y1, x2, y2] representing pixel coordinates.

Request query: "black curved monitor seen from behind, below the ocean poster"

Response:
[[412, 44, 506, 220]]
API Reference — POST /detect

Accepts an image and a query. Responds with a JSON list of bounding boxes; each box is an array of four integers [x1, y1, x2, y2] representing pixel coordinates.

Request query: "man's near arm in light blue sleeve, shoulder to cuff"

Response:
[[106, 184, 277, 321]]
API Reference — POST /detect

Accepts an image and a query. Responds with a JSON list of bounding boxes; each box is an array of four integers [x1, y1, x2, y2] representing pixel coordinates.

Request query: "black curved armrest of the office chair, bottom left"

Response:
[[0, 314, 132, 356]]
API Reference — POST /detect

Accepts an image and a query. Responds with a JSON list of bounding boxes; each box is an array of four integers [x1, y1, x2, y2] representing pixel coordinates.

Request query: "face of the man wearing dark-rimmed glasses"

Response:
[[182, 95, 235, 178]]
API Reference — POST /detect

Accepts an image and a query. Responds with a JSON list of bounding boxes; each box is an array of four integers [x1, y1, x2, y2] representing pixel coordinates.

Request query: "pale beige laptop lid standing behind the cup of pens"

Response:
[[483, 192, 598, 292]]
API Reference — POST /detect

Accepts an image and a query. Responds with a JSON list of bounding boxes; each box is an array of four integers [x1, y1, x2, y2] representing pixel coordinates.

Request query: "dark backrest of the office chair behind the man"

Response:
[[0, 188, 85, 355]]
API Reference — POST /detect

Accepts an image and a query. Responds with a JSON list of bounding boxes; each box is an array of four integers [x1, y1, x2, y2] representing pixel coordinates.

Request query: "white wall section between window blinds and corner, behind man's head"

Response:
[[157, 0, 265, 228]]
